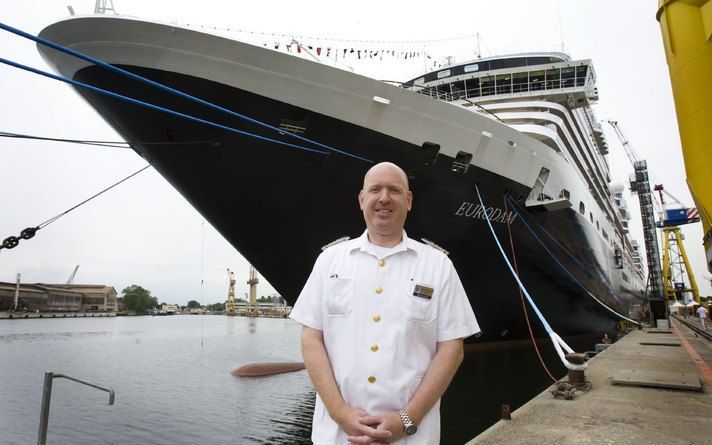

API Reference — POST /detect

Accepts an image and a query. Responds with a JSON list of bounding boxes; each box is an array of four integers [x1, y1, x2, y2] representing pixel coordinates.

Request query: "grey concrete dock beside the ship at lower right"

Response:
[[466, 319, 712, 445]]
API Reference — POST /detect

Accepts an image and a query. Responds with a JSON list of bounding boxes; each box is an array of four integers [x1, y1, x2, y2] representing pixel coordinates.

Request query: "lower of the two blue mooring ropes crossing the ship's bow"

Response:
[[0, 57, 329, 155]]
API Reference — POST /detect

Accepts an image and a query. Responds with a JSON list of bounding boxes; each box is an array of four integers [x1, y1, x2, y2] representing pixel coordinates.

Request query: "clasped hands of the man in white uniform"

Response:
[[334, 406, 405, 445]]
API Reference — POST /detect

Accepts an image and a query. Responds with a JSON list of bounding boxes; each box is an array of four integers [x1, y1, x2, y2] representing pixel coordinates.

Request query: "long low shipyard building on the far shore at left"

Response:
[[0, 281, 117, 312]]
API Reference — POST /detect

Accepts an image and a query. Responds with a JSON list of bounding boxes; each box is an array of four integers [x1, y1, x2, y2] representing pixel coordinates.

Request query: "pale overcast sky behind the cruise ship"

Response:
[[0, 0, 712, 304]]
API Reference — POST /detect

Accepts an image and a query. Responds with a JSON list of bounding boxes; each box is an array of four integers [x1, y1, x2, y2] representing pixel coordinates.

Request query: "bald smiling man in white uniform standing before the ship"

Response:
[[290, 163, 480, 445]]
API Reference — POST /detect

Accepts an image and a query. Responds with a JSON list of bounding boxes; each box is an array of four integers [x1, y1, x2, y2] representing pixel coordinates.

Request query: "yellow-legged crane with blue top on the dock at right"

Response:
[[655, 184, 700, 303]]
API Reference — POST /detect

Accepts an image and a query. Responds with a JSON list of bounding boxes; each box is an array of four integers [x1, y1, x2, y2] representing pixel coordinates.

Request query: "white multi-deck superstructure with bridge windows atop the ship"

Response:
[[404, 52, 643, 287]]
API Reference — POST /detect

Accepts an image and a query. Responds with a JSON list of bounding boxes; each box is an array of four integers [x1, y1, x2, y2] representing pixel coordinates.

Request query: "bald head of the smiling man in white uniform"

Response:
[[358, 163, 413, 236]]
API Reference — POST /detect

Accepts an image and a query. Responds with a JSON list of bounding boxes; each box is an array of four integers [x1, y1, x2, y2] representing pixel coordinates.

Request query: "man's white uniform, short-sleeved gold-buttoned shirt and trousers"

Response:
[[290, 232, 480, 445]]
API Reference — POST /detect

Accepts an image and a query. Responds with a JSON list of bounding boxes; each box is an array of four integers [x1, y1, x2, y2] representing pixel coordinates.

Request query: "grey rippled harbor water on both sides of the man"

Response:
[[0, 316, 588, 445]]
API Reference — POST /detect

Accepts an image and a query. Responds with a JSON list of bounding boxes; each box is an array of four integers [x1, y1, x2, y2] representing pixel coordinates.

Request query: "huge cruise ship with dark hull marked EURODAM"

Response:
[[38, 15, 644, 342]]
